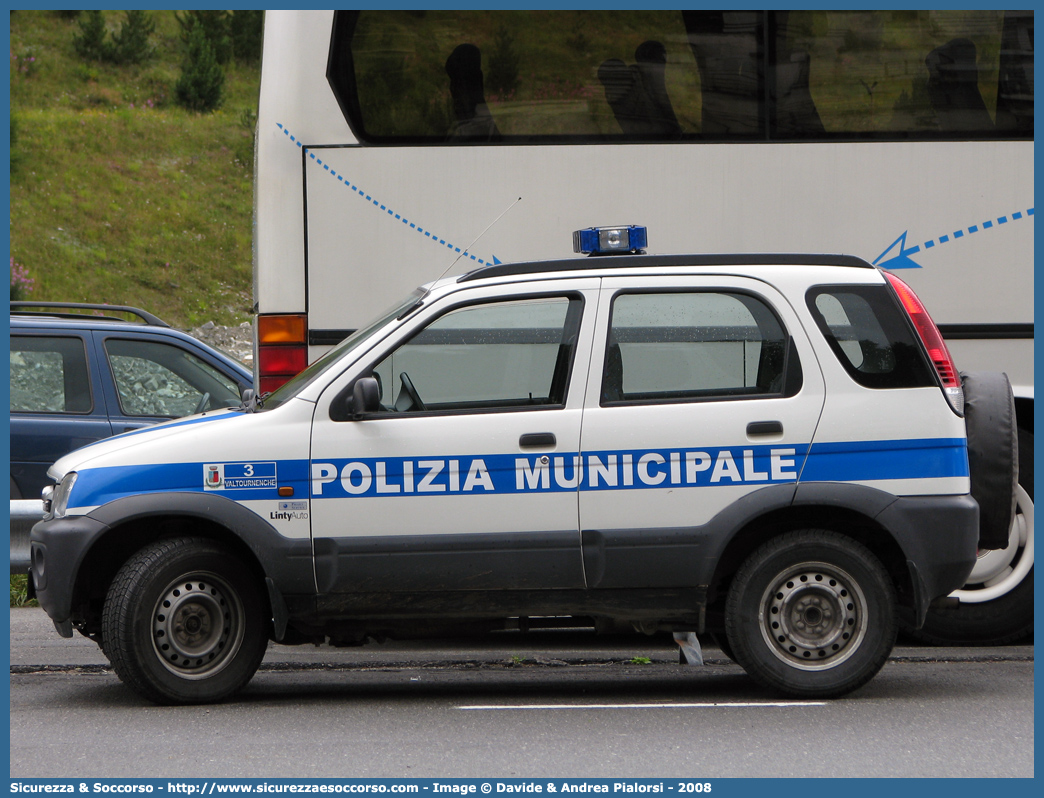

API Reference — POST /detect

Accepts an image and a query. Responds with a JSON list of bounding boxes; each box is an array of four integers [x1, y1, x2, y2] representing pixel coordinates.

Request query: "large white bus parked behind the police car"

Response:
[[254, 10, 1034, 643]]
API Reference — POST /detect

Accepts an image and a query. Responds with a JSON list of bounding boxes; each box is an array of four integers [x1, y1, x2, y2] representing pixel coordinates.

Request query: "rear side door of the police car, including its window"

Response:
[[579, 276, 824, 588]]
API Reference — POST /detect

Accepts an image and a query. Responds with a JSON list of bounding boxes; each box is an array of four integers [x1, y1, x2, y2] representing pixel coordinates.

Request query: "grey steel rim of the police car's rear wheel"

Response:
[[758, 562, 868, 671]]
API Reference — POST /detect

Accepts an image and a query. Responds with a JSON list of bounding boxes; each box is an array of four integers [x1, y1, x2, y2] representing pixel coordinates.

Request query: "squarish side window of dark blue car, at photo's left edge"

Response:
[[10, 335, 94, 414]]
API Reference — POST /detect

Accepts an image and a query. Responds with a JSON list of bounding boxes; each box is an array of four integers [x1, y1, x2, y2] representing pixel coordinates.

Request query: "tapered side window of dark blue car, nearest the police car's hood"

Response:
[[105, 338, 240, 418]]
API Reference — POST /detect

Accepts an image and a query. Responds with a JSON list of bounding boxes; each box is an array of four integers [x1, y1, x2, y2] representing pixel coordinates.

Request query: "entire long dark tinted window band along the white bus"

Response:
[[328, 10, 1033, 143]]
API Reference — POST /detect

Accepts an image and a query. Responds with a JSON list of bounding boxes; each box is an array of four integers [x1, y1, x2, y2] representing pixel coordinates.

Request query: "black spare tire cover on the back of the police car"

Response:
[[960, 372, 1019, 548]]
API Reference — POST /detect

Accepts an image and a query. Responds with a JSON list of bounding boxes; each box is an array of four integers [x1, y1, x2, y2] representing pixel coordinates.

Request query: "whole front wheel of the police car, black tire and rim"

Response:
[[101, 538, 268, 704]]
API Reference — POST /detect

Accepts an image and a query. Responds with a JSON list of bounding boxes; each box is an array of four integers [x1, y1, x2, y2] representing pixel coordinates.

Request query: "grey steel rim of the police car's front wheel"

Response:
[[152, 571, 244, 679]]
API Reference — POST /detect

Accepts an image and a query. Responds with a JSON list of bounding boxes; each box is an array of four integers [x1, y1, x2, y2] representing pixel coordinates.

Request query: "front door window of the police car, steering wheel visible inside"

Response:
[[373, 297, 582, 414]]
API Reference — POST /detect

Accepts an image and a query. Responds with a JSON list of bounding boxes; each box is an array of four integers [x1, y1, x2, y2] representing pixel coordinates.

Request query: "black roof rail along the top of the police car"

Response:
[[457, 253, 876, 283]]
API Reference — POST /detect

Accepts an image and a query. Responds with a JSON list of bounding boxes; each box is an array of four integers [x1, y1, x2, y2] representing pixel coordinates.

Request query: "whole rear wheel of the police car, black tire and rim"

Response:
[[726, 530, 897, 698]]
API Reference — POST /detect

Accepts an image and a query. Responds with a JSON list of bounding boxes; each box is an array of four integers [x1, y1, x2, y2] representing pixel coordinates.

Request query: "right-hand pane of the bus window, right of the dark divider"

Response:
[[774, 10, 1033, 138]]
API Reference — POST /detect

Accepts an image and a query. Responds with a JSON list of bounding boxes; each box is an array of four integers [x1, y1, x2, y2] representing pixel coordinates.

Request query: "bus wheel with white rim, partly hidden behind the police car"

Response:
[[907, 429, 1034, 646]]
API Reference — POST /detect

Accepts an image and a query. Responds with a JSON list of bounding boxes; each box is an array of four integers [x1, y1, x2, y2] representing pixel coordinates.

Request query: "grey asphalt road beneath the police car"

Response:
[[10, 609, 1034, 779]]
